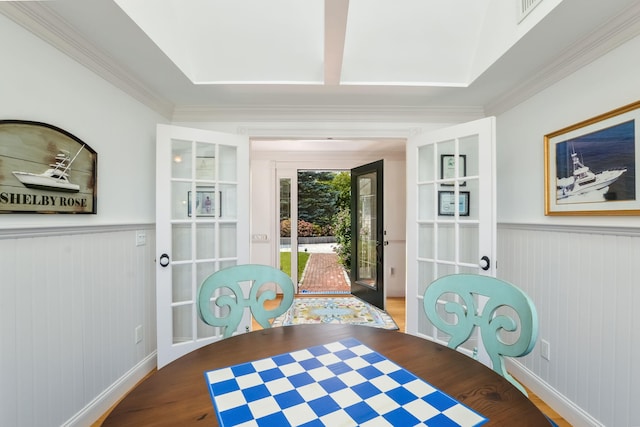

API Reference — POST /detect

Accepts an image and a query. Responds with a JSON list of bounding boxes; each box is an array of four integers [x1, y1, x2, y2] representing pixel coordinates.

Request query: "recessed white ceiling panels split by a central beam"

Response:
[[116, 0, 516, 87]]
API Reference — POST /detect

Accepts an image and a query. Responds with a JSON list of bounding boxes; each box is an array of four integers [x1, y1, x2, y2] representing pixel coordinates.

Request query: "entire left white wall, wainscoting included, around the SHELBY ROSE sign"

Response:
[[0, 15, 165, 427]]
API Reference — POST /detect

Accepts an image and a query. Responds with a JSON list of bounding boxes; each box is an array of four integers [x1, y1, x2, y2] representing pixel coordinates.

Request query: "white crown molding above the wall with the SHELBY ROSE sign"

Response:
[[0, 2, 173, 118]]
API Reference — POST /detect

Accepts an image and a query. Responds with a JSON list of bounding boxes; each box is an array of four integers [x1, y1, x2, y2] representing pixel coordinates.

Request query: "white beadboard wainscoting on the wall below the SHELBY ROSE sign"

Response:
[[0, 225, 156, 427]]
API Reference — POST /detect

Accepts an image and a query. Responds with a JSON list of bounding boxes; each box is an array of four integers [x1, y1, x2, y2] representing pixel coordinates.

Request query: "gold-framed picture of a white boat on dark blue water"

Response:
[[544, 102, 640, 215]]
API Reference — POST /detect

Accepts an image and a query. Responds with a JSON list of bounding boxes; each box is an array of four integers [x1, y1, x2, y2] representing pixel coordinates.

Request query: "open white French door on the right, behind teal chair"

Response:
[[406, 117, 496, 356]]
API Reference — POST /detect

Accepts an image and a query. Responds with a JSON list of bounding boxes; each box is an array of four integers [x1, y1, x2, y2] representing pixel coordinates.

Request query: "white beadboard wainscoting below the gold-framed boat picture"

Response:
[[497, 225, 640, 426]]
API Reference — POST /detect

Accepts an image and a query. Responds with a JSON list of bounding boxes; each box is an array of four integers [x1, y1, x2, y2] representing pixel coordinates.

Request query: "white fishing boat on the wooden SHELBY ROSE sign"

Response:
[[13, 145, 84, 193]]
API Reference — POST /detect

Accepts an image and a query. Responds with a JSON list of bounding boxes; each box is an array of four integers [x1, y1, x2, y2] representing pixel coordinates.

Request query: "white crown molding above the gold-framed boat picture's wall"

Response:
[[485, 2, 640, 115]]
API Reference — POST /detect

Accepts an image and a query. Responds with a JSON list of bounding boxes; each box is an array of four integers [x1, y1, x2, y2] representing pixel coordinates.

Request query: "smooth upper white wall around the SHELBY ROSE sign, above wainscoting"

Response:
[[0, 15, 166, 228]]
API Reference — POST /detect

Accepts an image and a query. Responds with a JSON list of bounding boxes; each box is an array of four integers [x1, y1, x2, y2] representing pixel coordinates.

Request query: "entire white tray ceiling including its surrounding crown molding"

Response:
[[0, 0, 640, 119]]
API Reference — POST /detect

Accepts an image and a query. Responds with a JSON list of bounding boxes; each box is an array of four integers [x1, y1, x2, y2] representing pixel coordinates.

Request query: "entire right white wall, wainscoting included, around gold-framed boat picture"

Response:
[[497, 31, 640, 426]]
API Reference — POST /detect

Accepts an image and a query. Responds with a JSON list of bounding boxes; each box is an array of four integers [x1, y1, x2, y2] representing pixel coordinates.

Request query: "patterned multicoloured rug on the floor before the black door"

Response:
[[272, 297, 398, 330]]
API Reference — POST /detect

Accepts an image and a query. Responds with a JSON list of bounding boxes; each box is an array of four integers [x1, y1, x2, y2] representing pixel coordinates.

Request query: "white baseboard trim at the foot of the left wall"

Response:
[[62, 351, 158, 427]]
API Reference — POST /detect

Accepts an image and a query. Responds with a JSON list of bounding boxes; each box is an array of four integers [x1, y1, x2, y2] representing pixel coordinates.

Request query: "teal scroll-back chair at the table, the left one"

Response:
[[198, 264, 295, 338]]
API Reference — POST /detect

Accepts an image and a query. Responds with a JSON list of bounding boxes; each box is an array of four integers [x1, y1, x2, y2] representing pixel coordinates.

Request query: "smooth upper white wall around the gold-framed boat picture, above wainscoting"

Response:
[[496, 33, 640, 227]]
